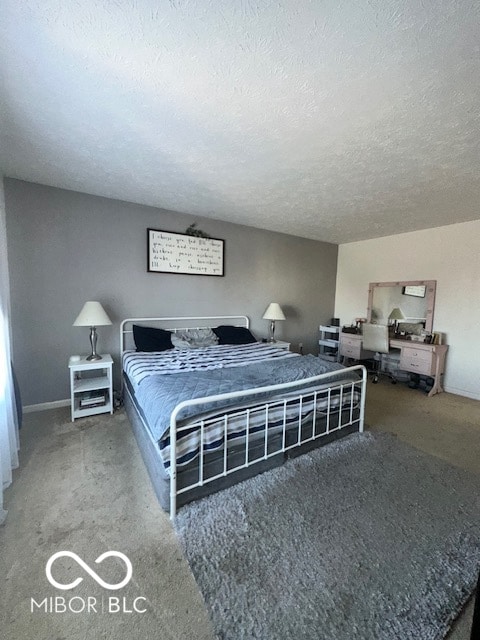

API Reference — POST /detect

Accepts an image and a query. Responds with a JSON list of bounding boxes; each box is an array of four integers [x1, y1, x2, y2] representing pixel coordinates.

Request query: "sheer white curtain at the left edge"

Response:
[[0, 176, 19, 524]]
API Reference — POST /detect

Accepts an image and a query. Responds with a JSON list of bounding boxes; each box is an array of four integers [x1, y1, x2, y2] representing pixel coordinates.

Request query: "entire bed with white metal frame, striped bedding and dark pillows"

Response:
[[120, 316, 366, 519]]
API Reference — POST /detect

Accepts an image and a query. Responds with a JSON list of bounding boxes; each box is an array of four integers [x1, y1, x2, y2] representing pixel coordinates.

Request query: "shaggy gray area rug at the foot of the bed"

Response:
[[176, 433, 480, 640]]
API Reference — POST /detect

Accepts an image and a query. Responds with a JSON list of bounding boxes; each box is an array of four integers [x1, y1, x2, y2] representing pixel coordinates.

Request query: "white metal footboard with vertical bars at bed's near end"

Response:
[[170, 365, 367, 520]]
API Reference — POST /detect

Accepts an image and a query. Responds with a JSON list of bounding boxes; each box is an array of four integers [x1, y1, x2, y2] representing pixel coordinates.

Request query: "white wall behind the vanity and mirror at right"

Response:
[[335, 220, 480, 400]]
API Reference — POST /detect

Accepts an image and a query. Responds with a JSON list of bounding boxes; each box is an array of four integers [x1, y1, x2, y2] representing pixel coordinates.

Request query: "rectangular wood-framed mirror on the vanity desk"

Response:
[[367, 280, 437, 333]]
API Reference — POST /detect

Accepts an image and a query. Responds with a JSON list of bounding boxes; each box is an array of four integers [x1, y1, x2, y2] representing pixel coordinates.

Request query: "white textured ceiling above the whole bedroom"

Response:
[[0, 0, 480, 243]]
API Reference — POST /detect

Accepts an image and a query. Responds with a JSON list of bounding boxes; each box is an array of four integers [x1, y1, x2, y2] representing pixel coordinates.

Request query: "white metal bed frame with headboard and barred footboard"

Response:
[[120, 316, 367, 520]]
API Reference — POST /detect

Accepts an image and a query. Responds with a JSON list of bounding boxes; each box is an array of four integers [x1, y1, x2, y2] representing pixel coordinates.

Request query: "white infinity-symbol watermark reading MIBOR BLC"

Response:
[[30, 551, 147, 614]]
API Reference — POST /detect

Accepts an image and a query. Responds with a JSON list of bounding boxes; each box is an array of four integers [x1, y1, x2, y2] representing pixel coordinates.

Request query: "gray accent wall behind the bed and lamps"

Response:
[[5, 179, 338, 405]]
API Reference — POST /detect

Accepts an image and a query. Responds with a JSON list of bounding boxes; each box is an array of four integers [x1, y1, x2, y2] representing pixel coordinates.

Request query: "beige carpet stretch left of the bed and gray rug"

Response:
[[0, 409, 213, 640]]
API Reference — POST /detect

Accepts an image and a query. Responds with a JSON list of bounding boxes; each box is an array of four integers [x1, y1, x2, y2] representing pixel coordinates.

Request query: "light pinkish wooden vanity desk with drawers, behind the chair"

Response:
[[339, 333, 448, 396]]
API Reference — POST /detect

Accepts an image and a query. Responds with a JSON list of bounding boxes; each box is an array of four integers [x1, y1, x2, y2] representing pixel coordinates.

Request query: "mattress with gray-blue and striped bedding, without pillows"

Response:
[[123, 343, 360, 476]]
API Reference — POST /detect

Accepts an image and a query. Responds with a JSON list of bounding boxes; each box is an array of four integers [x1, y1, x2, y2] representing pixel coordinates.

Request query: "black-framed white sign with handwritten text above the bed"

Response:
[[148, 229, 224, 276]]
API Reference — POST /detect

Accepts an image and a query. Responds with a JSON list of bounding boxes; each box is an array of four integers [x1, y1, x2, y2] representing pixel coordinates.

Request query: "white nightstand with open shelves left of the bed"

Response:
[[68, 353, 113, 422]]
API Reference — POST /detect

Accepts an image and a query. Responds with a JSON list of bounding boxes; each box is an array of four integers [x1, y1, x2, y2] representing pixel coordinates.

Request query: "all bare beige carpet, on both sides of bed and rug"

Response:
[[0, 382, 480, 640]]
